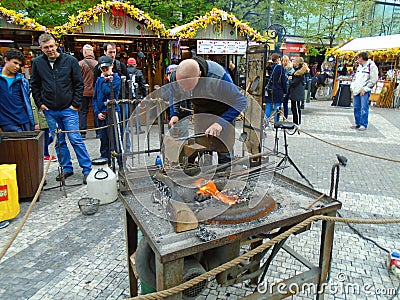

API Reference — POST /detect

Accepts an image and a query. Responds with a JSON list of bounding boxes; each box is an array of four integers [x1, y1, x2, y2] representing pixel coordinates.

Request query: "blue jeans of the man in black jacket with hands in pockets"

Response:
[[43, 108, 92, 175]]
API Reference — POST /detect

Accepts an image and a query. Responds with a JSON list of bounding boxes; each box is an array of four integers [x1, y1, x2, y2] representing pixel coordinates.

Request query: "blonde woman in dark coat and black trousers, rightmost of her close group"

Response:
[[289, 57, 309, 125]]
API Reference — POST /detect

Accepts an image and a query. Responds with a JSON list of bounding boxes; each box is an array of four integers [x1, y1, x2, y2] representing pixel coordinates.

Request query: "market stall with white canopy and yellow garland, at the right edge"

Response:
[[326, 34, 400, 107]]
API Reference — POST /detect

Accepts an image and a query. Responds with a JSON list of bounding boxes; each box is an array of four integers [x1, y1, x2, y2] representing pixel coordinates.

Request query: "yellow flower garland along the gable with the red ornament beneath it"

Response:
[[51, 1, 167, 38]]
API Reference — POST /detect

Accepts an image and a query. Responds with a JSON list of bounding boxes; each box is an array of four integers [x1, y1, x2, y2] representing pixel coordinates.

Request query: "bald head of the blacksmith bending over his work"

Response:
[[176, 59, 201, 91]]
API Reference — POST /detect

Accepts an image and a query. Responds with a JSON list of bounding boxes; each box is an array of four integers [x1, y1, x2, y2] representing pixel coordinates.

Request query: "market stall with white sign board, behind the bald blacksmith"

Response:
[[168, 8, 265, 88]]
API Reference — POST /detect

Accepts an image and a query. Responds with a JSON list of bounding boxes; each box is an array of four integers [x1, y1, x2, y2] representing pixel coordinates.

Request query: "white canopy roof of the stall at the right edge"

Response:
[[338, 34, 400, 51]]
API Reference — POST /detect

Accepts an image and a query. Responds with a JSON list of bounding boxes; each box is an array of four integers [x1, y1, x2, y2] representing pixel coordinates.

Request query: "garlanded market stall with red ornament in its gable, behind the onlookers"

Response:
[[52, 1, 167, 91]]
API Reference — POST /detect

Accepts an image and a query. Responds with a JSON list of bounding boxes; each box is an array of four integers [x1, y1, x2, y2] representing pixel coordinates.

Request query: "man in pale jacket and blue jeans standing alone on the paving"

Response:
[[350, 52, 378, 131]]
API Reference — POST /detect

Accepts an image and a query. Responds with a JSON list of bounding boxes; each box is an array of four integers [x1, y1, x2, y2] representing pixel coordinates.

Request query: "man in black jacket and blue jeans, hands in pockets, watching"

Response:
[[31, 33, 92, 184]]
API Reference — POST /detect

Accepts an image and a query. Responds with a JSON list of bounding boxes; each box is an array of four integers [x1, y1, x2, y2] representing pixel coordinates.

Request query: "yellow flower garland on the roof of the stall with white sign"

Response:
[[169, 8, 266, 42]]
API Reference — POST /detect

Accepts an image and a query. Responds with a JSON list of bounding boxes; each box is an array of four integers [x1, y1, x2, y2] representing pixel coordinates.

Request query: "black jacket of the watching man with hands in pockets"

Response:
[[31, 53, 84, 110]]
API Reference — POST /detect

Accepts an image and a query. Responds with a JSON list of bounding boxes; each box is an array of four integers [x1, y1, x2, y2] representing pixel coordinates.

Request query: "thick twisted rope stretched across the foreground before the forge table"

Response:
[[128, 215, 400, 300]]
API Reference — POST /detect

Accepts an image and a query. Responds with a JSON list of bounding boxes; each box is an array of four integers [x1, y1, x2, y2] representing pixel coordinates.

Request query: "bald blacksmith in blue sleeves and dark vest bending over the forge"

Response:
[[169, 57, 246, 164]]
